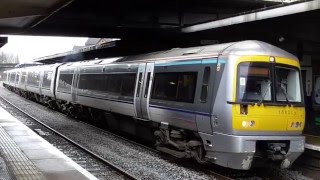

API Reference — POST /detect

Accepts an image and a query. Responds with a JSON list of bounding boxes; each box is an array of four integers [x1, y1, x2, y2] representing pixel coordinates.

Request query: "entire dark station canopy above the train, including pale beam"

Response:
[[0, 0, 320, 63]]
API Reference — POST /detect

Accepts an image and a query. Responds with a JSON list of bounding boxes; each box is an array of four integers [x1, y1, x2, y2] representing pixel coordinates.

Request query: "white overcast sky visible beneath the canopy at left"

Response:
[[0, 35, 88, 63]]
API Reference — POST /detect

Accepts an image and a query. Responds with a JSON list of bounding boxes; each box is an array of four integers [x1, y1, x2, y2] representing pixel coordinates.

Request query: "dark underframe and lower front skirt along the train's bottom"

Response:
[[5, 85, 304, 170]]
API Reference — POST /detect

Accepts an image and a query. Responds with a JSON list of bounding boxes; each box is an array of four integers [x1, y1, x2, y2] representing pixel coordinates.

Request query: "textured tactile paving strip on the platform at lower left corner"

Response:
[[0, 126, 46, 180]]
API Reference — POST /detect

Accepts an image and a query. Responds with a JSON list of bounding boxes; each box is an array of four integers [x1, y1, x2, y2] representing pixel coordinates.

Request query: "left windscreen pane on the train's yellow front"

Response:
[[237, 63, 271, 102]]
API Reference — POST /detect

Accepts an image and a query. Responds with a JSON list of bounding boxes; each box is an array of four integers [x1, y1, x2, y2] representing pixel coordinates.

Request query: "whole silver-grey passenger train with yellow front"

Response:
[[3, 40, 305, 170]]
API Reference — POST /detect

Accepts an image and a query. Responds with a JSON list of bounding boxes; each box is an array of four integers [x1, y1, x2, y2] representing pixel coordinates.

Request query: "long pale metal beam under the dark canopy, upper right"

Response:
[[181, 0, 320, 33]]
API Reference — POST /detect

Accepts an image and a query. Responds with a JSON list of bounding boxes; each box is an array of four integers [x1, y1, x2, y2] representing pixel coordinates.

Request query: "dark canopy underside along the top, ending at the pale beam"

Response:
[[0, 0, 305, 38]]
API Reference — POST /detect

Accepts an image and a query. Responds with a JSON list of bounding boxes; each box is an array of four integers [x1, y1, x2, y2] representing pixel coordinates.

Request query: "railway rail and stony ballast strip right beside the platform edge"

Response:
[[0, 96, 138, 180]]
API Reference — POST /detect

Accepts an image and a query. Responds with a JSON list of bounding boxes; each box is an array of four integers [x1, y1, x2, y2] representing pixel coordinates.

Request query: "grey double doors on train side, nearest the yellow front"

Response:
[[134, 63, 154, 119]]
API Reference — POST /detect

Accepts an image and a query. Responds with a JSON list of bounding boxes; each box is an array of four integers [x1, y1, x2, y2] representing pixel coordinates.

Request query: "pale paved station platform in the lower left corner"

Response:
[[0, 107, 97, 180]]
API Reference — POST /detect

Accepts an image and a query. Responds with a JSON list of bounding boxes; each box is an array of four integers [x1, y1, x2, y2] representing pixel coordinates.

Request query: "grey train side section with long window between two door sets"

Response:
[[76, 64, 138, 117]]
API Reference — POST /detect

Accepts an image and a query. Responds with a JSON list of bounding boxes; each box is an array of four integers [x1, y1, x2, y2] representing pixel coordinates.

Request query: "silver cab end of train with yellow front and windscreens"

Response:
[[199, 41, 305, 169]]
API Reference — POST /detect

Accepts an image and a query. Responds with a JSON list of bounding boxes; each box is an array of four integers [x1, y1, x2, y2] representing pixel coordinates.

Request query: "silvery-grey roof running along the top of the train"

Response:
[[7, 40, 298, 71]]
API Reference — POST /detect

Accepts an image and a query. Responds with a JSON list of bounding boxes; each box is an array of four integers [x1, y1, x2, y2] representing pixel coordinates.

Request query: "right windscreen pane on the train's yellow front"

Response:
[[275, 67, 302, 102]]
